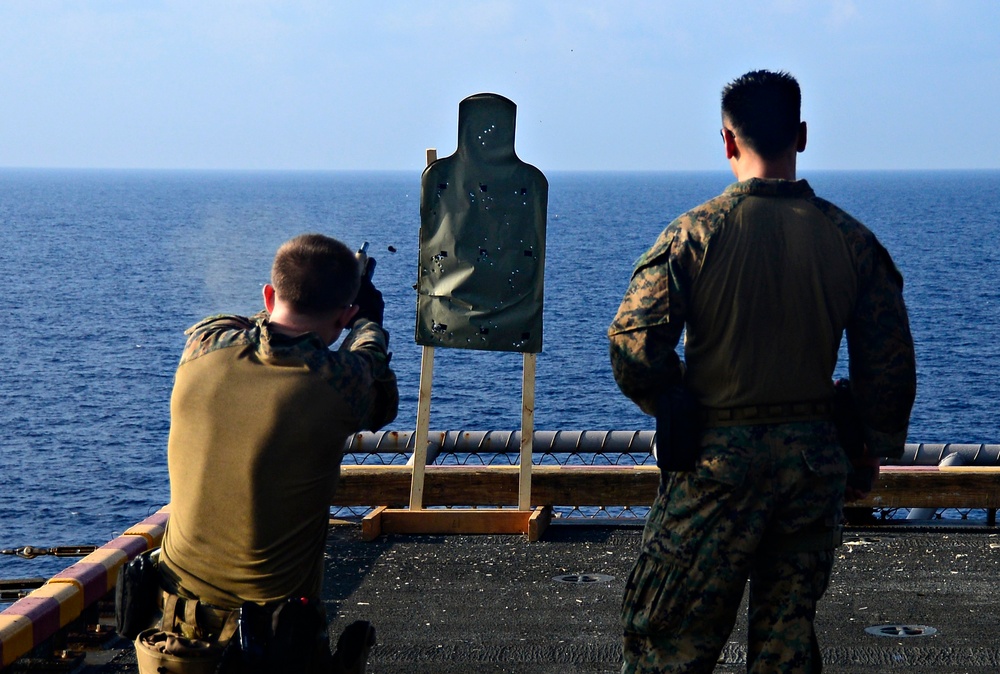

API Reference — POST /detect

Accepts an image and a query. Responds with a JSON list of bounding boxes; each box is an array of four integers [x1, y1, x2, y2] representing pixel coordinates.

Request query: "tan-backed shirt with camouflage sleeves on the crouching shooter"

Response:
[[161, 313, 399, 608]]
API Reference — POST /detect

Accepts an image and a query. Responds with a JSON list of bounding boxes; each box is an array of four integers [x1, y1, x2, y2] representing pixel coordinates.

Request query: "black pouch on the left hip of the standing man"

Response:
[[655, 386, 701, 474]]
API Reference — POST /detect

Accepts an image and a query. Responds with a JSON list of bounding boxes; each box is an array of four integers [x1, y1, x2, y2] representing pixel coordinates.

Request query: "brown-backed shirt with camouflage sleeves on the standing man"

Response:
[[608, 179, 916, 456]]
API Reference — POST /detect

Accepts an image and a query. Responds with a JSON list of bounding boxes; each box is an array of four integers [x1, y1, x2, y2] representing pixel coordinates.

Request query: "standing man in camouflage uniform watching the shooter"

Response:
[[608, 70, 916, 673]]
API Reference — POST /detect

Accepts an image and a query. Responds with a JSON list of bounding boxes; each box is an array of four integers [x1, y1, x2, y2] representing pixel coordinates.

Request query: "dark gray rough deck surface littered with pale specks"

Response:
[[52, 524, 1000, 674]]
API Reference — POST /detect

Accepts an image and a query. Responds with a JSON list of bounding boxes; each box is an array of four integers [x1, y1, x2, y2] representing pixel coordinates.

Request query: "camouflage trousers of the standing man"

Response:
[[622, 421, 848, 674]]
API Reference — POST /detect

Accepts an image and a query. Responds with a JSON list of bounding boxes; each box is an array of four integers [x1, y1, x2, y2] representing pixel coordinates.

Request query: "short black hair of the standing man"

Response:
[[722, 70, 802, 159]]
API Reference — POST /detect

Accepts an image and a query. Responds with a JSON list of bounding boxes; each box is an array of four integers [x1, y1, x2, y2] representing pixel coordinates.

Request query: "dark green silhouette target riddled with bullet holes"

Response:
[[414, 94, 548, 353]]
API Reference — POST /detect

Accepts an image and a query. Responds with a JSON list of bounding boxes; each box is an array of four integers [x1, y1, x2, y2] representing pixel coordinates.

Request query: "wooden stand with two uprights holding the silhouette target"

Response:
[[361, 148, 552, 541]]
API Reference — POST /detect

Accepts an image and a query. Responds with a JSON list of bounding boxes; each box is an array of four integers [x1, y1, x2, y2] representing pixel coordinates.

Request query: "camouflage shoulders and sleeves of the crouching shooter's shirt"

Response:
[[180, 311, 399, 428]]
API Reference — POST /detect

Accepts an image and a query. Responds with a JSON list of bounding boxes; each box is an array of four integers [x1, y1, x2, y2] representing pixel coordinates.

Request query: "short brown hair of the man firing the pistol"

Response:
[[271, 234, 361, 316]]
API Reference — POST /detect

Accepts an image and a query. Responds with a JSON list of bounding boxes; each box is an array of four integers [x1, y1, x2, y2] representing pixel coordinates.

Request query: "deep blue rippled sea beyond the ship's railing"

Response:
[[0, 170, 1000, 579]]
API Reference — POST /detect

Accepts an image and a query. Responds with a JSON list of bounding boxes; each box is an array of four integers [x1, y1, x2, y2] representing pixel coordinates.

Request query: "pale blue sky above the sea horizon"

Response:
[[0, 0, 1000, 171]]
